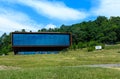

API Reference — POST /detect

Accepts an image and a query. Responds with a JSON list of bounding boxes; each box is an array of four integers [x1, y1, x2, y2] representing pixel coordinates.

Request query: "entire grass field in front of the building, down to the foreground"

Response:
[[0, 45, 120, 79]]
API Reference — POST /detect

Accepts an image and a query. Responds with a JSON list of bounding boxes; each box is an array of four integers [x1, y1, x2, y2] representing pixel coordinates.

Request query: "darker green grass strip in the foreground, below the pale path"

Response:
[[0, 67, 120, 79]]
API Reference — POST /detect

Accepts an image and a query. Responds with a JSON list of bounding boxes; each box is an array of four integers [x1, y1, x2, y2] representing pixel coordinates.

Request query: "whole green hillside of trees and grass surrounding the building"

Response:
[[0, 16, 120, 79]]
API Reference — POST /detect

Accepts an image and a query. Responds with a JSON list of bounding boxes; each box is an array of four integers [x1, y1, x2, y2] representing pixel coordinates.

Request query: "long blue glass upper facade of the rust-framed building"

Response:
[[12, 33, 70, 46]]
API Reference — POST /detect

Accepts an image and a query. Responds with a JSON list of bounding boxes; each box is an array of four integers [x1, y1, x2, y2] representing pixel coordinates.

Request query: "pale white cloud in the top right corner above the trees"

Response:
[[93, 0, 120, 17]]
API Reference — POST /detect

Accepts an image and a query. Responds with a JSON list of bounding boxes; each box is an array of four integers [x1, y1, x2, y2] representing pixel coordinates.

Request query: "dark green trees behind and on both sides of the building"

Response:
[[0, 16, 120, 53]]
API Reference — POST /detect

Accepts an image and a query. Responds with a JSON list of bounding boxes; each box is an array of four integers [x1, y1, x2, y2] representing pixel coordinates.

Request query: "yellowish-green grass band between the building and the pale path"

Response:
[[0, 49, 120, 68]]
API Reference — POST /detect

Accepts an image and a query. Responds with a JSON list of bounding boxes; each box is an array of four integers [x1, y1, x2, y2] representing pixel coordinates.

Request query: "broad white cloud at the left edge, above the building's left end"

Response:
[[0, 7, 40, 33]]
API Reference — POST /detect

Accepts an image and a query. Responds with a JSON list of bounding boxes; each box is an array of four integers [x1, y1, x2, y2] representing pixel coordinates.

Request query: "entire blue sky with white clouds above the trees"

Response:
[[0, 0, 120, 35]]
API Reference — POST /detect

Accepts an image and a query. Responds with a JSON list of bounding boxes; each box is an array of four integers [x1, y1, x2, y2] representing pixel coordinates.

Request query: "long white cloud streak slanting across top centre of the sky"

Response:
[[15, 0, 87, 21]]
